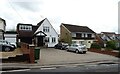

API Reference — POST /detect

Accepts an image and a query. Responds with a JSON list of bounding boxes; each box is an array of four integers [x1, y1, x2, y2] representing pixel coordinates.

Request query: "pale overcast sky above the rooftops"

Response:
[[0, 0, 120, 33]]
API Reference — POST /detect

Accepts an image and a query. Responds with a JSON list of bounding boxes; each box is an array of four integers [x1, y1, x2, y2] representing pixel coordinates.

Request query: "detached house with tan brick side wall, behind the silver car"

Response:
[[60, 23, 95, 48]]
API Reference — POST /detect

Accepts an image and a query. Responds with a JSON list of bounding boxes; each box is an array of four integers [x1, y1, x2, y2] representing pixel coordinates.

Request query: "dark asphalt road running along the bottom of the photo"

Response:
[[3, 64, 120, 74]]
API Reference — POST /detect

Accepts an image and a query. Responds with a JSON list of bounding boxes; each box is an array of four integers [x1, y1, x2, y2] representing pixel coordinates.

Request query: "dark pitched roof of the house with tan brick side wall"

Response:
[[62, 23, 95, 33]]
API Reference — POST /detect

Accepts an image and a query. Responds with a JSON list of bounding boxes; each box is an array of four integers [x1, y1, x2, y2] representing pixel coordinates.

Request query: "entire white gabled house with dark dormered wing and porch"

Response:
[[17, 18, 58, 47]]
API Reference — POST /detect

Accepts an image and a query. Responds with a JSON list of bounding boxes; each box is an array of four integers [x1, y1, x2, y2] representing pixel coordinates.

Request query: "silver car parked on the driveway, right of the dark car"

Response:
[[66, 44, 87, 54]]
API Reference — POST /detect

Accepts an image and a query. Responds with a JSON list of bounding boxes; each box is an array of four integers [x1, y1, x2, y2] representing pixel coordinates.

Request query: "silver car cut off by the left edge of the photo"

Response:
[[0, 40, 16, 52]]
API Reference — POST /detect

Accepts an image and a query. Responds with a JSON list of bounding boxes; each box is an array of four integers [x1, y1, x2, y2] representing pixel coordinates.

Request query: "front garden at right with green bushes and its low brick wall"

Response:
[[88, 40, 120, 58]]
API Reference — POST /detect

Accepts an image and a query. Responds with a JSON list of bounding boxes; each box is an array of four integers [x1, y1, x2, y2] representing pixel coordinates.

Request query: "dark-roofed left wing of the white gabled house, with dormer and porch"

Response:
[[17, 23, 46, 46]]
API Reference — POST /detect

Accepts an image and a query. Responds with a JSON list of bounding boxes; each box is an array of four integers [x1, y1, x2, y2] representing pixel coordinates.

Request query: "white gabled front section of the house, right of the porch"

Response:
[[35, 18, 58, 47]]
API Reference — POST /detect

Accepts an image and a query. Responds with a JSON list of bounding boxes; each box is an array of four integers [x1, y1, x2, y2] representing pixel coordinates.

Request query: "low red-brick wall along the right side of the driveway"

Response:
[[88, 48, 120, 57]]
